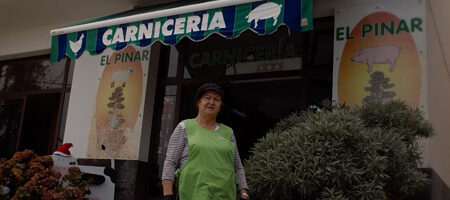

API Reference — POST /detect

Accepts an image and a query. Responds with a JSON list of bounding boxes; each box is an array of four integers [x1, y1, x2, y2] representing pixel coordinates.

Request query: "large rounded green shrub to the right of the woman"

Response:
[[245, 101, 433, 200]]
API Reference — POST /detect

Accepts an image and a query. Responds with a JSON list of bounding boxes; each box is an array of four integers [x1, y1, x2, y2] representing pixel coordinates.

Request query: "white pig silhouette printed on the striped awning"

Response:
[[245, 2, 283, 28]]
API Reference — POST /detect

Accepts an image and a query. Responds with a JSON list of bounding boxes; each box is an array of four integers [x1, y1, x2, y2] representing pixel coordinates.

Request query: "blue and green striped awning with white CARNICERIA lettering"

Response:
[[50, 0, 313, 62]]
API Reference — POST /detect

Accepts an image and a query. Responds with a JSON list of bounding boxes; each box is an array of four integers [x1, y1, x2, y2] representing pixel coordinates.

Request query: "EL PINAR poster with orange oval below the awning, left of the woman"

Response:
[[87, 45, 150, 160]]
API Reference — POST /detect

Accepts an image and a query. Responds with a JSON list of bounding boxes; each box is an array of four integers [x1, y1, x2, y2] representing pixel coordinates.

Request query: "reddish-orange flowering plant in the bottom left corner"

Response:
[[0, 150, 89, 200]]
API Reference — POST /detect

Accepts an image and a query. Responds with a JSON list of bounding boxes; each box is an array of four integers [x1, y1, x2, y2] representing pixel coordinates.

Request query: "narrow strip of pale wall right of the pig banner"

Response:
[[425, 0, 450, 186]]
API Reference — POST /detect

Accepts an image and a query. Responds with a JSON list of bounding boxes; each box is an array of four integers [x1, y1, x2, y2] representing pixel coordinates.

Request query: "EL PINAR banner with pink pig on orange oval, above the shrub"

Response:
[[333, 0, 426, 109]]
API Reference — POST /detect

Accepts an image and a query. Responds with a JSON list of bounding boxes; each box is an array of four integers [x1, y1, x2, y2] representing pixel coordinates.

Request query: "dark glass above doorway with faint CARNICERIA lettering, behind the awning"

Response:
[[177, 27, 302, 79]]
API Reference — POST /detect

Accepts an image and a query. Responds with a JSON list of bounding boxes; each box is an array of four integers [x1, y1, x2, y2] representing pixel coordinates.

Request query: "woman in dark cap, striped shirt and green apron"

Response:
[[162, 83, 249, 200]]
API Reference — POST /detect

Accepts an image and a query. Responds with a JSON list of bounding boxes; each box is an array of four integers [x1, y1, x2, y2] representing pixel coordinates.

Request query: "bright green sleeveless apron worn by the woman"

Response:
[[176, 119, 237, 200]]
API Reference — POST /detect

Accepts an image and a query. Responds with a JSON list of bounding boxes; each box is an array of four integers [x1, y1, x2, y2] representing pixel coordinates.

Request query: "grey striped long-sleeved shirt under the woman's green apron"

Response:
[[162, 122, 248, 190]]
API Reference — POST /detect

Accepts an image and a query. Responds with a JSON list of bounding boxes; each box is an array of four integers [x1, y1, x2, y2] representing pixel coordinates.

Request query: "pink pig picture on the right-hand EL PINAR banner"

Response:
[[351, 45, 401, 73]]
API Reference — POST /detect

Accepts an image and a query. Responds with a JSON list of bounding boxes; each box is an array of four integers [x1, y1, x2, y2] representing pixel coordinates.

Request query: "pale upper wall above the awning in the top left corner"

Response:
[[0, 0, 137, 60]]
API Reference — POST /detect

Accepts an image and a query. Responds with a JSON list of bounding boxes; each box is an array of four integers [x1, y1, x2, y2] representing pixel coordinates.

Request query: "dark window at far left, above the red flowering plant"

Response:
[[0, 55, 74, 157]]
